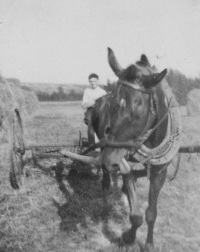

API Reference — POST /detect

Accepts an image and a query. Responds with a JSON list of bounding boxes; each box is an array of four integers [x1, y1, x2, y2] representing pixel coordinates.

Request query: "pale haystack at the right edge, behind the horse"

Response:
[[187, 89, 200, 116]]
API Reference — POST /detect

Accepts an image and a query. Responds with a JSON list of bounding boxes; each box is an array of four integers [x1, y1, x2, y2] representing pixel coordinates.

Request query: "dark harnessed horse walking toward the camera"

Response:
[[62, 48, 181, 252]]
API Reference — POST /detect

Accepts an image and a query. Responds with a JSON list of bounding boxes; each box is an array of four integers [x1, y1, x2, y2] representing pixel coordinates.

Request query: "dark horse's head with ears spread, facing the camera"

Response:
[[102, 48, 167, 170]]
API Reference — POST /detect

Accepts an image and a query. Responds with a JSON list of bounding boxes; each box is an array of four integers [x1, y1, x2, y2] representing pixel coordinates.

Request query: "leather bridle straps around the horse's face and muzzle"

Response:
[[83, 80, 170, 154]]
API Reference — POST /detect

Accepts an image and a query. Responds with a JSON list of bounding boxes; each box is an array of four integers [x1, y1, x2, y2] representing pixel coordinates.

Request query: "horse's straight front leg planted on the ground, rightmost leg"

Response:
[[145, 166, 167, 252]]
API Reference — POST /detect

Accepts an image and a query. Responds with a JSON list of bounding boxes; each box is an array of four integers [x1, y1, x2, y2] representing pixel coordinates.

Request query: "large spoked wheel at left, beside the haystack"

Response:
[[10, 109, 25, 189]]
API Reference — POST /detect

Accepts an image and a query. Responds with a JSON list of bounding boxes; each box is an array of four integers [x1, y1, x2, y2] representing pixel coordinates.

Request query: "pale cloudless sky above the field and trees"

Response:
[[0, 0, 200, 84]]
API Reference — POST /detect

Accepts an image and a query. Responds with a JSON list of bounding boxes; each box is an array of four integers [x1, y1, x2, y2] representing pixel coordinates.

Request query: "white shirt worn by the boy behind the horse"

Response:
[[82, 86, 107, 109]]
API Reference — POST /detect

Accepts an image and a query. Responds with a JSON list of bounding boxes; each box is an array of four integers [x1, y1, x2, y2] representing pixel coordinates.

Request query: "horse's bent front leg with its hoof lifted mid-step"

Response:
[[122, 172, 143, 244]]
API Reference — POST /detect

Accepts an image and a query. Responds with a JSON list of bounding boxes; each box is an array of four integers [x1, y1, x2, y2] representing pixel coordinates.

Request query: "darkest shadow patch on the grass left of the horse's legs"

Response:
[[54, 163, 103, 229]]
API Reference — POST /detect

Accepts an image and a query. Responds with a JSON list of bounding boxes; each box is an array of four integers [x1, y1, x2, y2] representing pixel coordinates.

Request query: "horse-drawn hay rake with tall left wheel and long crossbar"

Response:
[[10, 112, 200, 189]]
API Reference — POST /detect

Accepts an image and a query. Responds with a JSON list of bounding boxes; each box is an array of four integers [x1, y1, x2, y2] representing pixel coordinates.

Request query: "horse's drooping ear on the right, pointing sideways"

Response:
[[143, 69, 167, 88]]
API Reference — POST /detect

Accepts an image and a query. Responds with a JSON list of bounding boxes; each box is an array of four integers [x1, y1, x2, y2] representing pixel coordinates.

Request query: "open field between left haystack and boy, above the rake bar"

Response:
[[25, 101, 86, 147]]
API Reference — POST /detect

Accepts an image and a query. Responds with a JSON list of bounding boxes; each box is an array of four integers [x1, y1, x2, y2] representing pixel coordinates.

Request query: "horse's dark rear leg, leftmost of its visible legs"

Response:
[[101, 167, 110, 215]]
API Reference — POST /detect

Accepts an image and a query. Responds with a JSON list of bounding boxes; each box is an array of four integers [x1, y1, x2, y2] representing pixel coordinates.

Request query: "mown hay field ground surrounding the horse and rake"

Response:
[[0, 102, 200, 252]]
